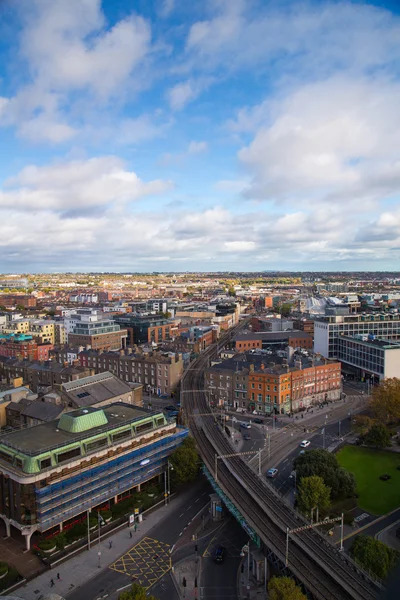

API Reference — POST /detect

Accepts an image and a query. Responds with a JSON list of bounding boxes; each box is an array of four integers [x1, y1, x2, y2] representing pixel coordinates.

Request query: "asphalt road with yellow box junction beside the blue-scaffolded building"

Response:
[[67, 478, 212, 600]]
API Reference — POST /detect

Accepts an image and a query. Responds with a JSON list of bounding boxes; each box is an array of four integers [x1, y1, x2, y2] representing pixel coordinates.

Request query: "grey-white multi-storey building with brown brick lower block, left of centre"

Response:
[[64, 308, 128, 350]]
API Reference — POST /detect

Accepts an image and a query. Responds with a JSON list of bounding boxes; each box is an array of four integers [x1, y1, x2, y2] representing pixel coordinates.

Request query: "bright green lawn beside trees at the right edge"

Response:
[[337, 446, 400, 515]]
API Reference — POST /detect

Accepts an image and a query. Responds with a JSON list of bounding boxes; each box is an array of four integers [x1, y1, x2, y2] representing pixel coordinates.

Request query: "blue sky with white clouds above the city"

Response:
[[0, 0, 400, 273]]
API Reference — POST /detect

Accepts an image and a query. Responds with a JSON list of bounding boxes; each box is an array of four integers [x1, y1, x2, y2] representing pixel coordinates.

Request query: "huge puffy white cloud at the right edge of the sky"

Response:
[[239, 77, 400, 209]]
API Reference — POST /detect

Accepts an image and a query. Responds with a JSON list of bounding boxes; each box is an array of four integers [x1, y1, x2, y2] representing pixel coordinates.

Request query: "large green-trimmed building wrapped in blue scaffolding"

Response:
[[0, 402, 188, 550]]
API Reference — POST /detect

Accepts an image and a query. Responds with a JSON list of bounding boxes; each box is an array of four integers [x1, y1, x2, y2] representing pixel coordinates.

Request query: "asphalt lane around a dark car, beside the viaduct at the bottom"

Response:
[[199, 517, 248, 600]]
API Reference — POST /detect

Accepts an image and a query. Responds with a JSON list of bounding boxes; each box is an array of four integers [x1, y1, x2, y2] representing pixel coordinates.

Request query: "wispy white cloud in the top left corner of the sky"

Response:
[[0, 0, 151, 143]]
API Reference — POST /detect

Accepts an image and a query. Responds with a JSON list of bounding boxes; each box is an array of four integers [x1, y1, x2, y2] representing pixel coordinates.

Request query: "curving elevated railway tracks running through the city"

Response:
[[183, 324, 379, 600]]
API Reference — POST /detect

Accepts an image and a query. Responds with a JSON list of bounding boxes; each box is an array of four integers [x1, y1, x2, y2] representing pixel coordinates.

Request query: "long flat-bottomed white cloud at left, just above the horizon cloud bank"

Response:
[[0, 156, 172, 213]]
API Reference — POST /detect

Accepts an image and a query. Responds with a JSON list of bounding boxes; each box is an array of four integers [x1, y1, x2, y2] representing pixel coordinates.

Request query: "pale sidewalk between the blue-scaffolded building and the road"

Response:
[[13, 495, 194, 600]]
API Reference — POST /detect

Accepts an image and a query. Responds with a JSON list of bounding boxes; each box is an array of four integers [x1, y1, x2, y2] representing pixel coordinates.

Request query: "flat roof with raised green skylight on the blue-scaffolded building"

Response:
[[0, 402, 159, 455]]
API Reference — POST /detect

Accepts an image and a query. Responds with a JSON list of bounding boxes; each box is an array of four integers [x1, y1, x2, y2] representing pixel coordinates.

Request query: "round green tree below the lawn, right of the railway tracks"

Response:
[[350, 535, 399, 579]]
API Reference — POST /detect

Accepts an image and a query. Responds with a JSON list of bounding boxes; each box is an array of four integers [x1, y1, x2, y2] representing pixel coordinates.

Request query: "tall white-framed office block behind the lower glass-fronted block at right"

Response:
[[314, 313, 400, 358]]
